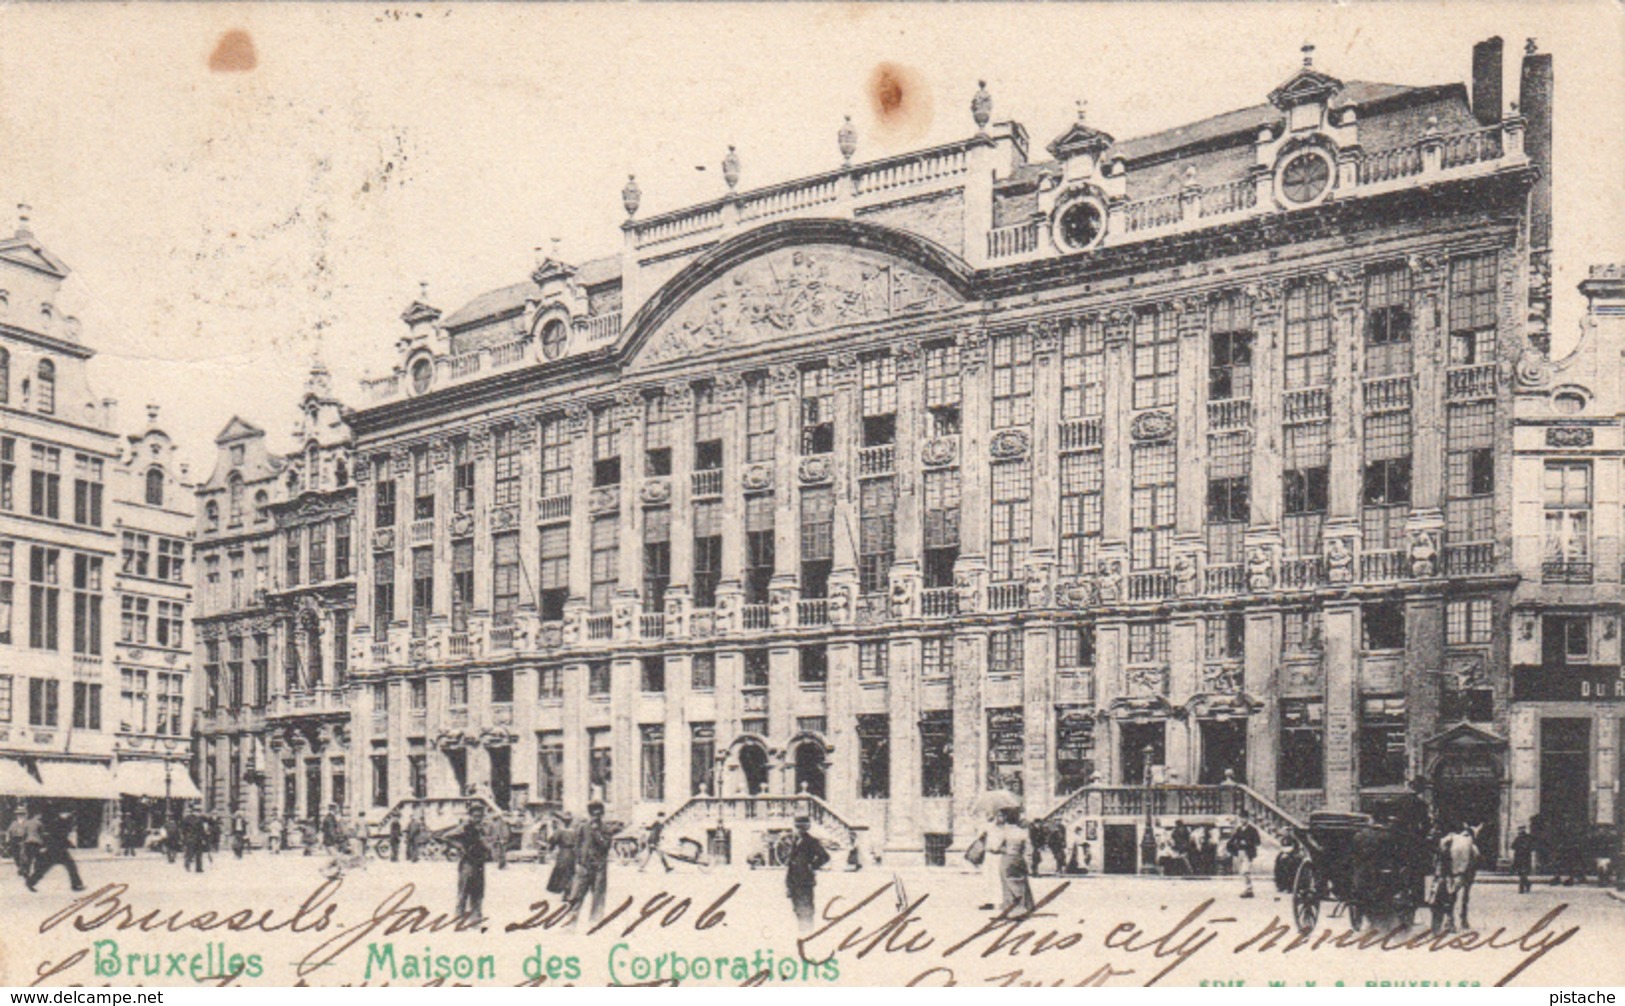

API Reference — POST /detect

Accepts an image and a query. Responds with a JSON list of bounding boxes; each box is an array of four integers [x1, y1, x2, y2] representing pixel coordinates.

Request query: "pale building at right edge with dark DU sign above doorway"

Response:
[[1508, 265, 1625, 855]]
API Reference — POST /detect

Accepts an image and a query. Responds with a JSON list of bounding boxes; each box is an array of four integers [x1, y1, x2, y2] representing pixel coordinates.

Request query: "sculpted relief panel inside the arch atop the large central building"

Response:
[[642, 245, 959, 364]]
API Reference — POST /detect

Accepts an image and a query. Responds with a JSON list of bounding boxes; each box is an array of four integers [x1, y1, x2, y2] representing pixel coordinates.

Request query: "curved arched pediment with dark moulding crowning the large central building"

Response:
[[626, 221, 970, 367]]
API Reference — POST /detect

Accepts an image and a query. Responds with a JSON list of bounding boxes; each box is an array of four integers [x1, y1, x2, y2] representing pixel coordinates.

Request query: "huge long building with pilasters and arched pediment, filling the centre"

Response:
[[351, 39, 1550, 869]]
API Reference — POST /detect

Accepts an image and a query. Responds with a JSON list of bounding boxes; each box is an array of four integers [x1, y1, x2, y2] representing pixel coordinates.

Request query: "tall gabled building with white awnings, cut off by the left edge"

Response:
[[0, 211, 120, 845]]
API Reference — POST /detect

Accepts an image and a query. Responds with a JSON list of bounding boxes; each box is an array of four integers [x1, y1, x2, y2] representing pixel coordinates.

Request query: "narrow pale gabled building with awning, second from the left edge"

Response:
[[107, 405, 200, 834]]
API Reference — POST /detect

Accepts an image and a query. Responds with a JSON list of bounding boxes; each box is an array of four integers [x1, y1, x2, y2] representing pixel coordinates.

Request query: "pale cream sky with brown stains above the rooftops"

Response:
[[0, 0, 1625, 473]]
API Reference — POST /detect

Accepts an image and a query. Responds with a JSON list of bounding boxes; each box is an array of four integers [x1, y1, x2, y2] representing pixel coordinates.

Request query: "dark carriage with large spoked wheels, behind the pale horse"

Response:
[[1276, 811, 1425, 933]]
